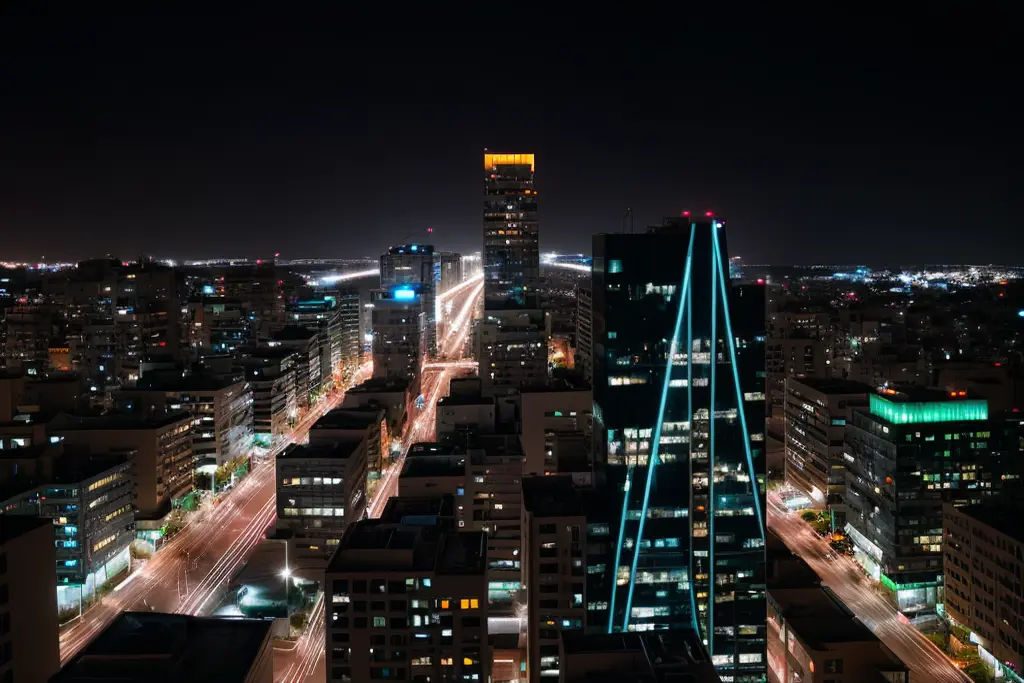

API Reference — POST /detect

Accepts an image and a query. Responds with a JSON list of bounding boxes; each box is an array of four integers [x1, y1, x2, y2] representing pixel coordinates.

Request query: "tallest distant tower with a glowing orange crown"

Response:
[[483, 153, 541, 309]]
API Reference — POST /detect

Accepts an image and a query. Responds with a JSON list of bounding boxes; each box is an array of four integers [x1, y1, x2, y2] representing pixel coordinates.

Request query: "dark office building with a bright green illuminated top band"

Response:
[[844, 392, 1020, 615]]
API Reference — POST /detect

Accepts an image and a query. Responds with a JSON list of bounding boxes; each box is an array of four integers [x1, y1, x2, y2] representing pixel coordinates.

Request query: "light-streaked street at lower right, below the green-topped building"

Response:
[[768, 495, 971, 683]]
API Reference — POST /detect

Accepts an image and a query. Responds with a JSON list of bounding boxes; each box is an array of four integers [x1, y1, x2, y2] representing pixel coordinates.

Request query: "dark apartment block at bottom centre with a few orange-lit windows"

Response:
[[325, 519, 490, 683]]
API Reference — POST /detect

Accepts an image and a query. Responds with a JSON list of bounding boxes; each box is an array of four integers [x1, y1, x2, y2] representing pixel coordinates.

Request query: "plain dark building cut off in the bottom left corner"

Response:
[[0, 514, 60, 683]]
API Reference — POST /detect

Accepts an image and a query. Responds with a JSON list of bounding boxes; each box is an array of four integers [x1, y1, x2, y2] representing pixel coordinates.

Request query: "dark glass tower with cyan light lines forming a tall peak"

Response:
[[588, 214, 766, 681]]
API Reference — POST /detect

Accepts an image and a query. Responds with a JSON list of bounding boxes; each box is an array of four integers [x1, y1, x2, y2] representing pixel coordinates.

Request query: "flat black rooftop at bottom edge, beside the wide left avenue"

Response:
[[50, 612, 271, 683]]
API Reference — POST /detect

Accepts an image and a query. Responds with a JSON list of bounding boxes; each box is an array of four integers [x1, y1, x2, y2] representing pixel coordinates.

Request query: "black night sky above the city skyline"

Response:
[[0, 12, 1024, 264]]
